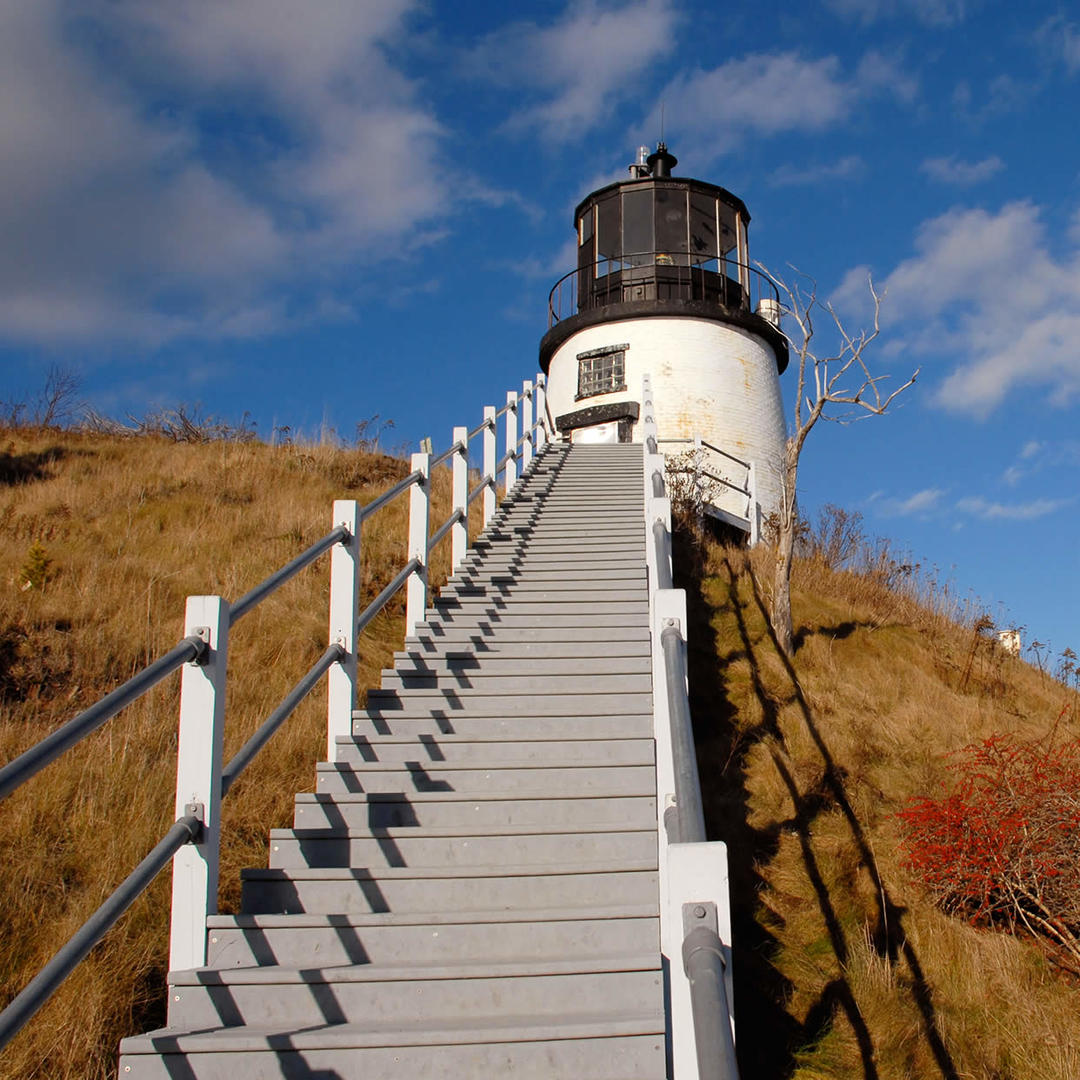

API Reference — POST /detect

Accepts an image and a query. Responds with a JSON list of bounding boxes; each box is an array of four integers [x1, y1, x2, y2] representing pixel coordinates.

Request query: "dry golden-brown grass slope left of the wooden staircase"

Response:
[[0, 430, 478, 1080]]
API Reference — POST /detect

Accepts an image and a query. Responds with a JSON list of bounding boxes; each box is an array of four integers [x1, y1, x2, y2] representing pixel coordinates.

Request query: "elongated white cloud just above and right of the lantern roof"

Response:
[[661, 52, 918, 157]]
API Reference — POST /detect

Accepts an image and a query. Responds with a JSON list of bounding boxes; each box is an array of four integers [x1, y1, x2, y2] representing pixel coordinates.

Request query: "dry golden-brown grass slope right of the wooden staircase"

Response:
[[686, 546, 1080, 1080]]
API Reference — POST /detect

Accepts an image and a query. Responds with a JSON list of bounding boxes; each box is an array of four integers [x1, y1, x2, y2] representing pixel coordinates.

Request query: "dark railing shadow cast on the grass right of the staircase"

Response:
[[708, 555, 959, 1080]]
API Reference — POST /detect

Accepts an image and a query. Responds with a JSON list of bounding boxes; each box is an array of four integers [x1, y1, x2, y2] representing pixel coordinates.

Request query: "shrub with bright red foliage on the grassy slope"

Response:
[[900, 713, 1080, 967]]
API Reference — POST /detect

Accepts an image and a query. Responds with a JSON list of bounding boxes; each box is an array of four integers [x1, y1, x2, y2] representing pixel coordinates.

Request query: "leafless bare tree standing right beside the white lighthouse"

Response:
[[758, 270, 919, 656]]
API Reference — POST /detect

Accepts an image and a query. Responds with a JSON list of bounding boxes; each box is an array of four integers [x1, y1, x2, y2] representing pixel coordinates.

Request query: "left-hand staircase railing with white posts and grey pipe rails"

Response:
[[0, 375, 550, 1048]]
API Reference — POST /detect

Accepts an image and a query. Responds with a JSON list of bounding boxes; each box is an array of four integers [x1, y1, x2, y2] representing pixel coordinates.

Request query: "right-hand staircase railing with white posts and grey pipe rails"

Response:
[[642, 376, 739, 1080]]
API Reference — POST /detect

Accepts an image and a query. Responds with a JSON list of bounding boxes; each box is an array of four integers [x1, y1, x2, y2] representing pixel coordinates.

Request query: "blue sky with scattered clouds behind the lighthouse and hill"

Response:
[[0, 0, 1080, 651]]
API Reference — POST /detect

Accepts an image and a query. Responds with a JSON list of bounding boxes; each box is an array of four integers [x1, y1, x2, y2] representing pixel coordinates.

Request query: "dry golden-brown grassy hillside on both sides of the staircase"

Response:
[[0, 431, 1080, 1080]]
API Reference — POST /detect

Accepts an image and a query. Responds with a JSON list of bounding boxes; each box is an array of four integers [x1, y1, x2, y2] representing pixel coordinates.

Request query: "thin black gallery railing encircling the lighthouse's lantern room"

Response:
[[548, 252, 780, 329]]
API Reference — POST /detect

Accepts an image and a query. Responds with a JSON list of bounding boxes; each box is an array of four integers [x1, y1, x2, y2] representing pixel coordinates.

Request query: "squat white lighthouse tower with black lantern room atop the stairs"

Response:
[[540, 143, 787, 541]]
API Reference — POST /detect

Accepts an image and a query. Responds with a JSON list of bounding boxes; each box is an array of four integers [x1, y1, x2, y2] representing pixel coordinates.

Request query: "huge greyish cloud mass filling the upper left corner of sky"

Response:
[[0, 0, 445, 345]]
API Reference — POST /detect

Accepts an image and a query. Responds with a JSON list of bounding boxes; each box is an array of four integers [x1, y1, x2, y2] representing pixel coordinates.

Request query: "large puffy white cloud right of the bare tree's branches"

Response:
[[834, 202, 1080, 416]]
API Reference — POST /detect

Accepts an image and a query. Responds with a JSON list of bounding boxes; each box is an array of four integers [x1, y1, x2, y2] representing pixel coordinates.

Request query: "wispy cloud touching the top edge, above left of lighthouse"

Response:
[[467, 0, 677, 143]]
